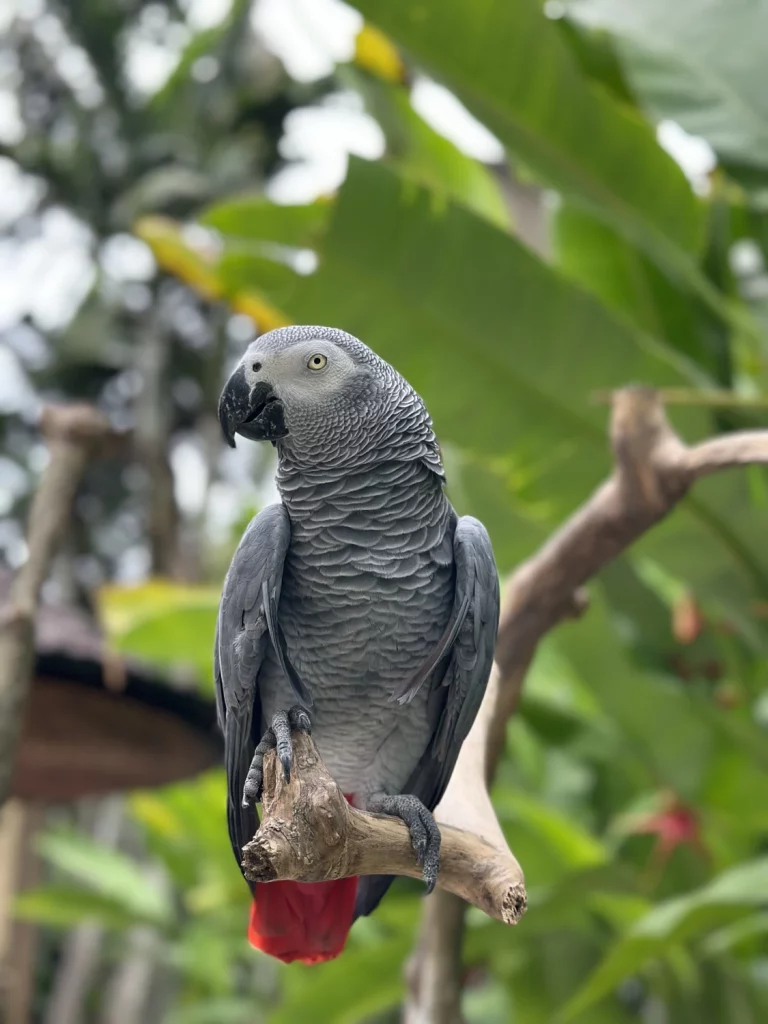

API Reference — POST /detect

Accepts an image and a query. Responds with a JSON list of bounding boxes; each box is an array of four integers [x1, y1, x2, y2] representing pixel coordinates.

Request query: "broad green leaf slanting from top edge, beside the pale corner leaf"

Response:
[[355, 0, 702, 252]]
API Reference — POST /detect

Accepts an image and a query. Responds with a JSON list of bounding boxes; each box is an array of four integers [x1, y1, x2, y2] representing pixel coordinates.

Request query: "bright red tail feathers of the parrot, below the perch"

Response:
[[248, 879, 357, 964]]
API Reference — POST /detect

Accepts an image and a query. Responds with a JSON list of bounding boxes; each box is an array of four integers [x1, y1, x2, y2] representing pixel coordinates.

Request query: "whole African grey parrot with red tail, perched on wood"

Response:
[[215, 327, 499, 963]]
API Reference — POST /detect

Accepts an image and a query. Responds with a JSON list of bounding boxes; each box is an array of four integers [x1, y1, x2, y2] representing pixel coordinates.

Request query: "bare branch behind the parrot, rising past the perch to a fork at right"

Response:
[[403, 388, 768, 1024]]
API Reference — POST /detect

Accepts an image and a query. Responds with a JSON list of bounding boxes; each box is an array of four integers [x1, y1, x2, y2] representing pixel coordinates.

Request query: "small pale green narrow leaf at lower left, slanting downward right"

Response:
[[38, 829, 173, 927]]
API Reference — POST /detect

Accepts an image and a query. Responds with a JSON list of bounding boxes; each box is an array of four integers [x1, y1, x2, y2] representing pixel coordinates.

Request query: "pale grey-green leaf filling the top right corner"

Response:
[[566, 0, 768, 167]]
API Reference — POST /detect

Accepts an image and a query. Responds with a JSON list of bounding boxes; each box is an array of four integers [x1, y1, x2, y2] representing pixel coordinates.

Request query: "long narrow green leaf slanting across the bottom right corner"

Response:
[[562, 858, 768, 1020]]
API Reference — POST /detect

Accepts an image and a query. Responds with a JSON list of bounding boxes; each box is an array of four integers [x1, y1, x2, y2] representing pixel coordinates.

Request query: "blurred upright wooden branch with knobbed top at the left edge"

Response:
[[0, 406, 110, 807]]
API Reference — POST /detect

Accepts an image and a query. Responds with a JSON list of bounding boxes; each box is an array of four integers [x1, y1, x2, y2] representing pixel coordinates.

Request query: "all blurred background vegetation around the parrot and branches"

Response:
[[0, 0, 768, 1024]]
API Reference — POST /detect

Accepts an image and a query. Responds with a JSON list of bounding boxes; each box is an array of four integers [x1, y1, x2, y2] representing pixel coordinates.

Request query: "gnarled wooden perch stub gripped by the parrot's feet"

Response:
[[243, 733, 525, 925]]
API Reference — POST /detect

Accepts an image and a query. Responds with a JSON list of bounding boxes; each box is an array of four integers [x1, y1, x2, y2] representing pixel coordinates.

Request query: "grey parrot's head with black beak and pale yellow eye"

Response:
[[219, 327, 442, 476]]
